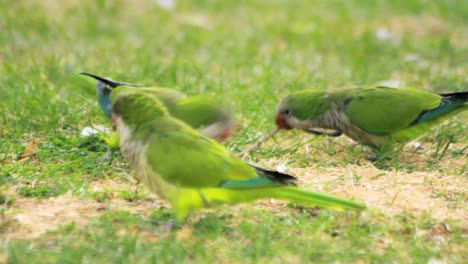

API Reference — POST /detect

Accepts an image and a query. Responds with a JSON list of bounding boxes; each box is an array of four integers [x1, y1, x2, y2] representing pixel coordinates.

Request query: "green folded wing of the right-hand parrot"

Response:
[[345, 87, 441, 135]]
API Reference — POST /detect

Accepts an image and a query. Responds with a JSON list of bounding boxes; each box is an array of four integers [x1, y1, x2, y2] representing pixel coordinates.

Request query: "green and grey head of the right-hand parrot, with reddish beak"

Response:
[[275, 90, 323, 130]]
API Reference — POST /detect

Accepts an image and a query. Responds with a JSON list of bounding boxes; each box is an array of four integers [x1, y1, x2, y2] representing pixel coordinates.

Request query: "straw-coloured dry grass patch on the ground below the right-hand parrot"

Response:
[[247, 131, 468, 226]]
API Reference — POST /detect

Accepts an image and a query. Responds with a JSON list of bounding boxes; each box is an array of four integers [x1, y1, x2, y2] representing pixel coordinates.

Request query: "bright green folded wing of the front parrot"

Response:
[[146, 116, 260, 188]]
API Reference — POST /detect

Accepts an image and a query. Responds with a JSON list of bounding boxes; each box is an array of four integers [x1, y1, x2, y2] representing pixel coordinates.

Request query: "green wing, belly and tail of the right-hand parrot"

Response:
[[346, 87, 468, 146]]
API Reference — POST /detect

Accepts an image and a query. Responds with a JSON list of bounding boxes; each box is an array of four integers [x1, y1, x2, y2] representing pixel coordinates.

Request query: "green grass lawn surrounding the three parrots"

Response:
[[0, 0, 468, 263]]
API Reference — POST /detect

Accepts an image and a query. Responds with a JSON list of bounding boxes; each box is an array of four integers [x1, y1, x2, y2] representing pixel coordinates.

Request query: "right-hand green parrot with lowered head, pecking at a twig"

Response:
[[276, 87, 468, 155]]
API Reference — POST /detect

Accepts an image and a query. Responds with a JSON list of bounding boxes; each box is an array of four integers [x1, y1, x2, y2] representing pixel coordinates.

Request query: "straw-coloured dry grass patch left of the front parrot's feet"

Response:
[[4, 180, 167, 240]]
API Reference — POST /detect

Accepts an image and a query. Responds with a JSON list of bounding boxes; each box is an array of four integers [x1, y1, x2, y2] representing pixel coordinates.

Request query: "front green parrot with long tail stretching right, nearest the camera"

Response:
[[111, 86, 365, 221]]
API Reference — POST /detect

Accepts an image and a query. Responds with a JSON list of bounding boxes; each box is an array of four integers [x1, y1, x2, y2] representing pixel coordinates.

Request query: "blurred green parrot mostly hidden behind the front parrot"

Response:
[[81, 72, 235, 161]]
